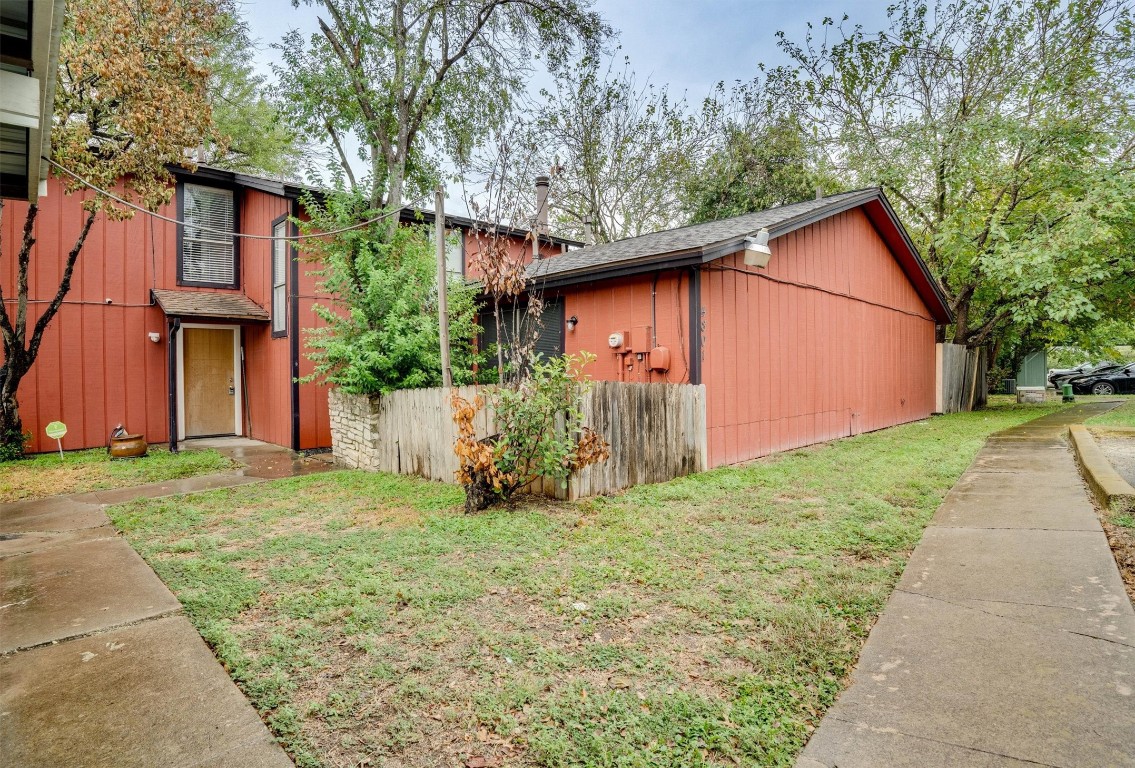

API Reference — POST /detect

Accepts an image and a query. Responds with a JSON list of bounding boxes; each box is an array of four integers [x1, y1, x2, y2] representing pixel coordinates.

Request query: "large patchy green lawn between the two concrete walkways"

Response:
[[110, 405, 1059, 768]]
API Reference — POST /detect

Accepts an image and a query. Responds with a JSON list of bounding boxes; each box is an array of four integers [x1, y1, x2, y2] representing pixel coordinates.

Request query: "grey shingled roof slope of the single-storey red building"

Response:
[[528, 188, 881, 279]]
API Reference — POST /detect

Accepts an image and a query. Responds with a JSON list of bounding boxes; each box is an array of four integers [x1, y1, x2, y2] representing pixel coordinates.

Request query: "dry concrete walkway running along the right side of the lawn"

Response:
[[797, 403, 1135, 768]]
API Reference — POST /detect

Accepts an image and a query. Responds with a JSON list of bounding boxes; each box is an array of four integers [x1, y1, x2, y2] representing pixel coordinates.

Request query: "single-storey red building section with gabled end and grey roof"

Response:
[[519, 189, 950, 466]]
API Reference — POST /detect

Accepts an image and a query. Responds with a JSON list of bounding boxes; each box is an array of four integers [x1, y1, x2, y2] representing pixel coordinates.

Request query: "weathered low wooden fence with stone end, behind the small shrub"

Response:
[[329, 381, 707, 499]]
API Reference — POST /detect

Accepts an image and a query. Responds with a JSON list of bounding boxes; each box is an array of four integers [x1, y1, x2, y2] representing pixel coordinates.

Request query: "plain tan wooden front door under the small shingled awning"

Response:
[[182, 328, 237, 438]]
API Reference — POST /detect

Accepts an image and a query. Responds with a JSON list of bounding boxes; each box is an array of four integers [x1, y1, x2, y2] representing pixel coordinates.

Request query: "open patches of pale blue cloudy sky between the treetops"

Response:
[[242, 0, 888, 205]]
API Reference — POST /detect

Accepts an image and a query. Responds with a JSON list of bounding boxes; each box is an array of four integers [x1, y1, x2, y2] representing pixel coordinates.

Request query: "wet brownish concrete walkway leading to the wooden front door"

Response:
[[0, 439, 329, 768]]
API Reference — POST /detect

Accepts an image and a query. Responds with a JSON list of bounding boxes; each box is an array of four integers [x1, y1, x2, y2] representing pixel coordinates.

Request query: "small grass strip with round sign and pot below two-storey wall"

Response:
[[0, 446, 235, 503]]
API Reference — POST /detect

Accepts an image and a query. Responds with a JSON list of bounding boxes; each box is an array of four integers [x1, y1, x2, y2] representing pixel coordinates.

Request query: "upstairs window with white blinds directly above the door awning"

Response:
[[182, 184, 237, 287]]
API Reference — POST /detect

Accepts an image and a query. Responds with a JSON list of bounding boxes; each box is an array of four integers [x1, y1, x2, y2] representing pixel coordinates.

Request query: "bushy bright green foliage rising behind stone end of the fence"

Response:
[[301, 193, 480, 395]]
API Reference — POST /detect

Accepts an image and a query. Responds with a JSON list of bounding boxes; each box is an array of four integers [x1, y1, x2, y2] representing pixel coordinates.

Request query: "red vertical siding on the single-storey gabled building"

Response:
[[553, 209, 935, 466]]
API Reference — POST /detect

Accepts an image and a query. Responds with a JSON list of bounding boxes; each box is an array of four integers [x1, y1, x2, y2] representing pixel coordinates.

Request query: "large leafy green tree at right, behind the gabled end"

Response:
[[771, 0, 1135, 346]]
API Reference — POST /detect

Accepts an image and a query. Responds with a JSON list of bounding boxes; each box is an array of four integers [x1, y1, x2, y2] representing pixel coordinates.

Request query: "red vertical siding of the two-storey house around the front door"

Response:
[[0, 178, 330, 451]]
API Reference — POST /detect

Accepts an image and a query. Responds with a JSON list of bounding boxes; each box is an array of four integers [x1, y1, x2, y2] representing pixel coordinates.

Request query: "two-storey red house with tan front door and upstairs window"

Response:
[[0, 167, 570, 451]]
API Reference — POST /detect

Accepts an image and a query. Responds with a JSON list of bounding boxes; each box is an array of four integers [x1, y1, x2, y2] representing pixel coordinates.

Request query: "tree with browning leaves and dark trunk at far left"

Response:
[[0, 0, 225, 455]]
